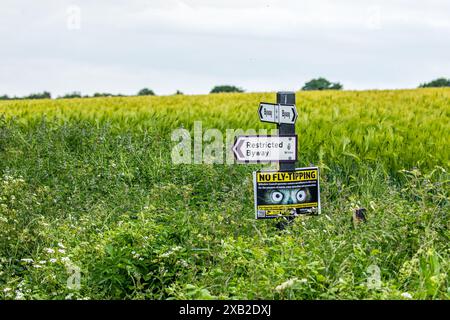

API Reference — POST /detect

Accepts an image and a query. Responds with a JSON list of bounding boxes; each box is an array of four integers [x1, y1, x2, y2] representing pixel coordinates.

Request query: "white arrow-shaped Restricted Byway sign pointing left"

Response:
[[233, 135, 297, 163]]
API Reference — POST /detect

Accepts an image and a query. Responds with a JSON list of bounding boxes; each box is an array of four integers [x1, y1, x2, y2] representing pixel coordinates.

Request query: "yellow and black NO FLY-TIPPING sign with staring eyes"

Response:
[[253, 167, 320, 219]]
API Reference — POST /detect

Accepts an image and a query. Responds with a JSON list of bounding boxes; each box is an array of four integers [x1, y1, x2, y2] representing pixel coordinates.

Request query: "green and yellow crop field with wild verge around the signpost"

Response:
[[0, 89, 450, 299]]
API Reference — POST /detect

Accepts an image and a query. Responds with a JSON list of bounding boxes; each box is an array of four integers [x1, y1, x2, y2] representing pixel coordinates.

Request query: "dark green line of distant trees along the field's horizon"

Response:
[[0, 77, 450, 100]]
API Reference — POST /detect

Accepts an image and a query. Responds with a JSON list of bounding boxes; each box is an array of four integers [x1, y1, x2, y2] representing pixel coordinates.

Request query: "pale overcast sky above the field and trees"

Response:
[[0, 0, 450, 96]]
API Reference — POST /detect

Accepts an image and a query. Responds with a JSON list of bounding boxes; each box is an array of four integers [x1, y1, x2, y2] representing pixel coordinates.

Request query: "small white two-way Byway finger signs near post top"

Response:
[[258, 102, 298, 124]]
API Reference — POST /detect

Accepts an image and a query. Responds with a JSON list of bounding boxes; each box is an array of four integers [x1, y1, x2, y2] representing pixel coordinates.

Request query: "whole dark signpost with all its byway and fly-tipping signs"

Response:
[[233, 92, 320, 221]]
